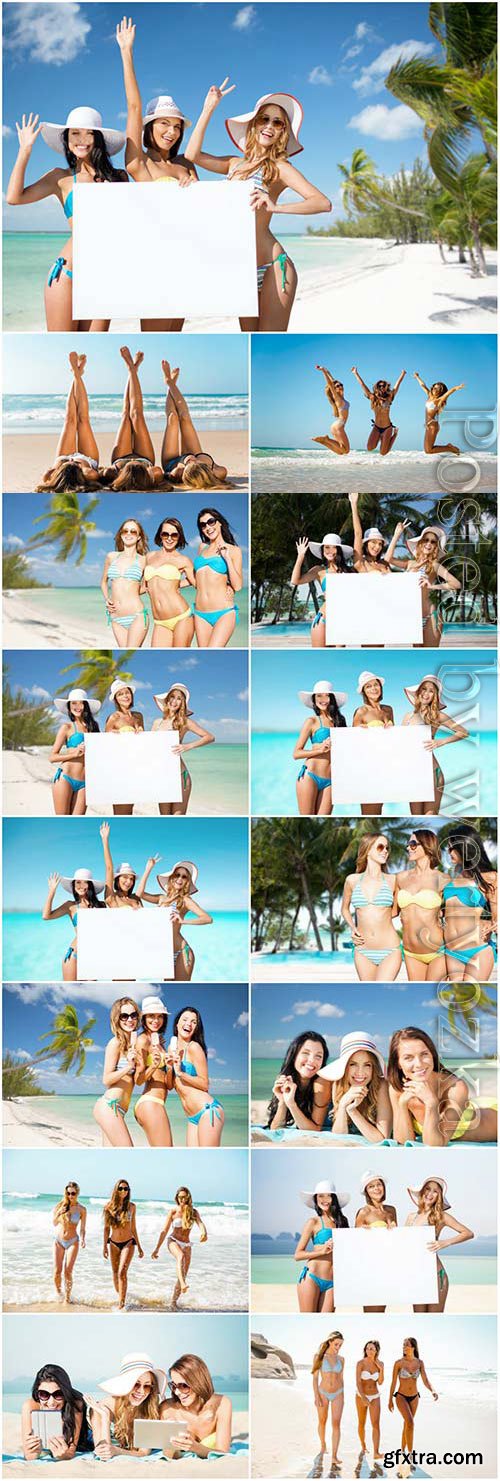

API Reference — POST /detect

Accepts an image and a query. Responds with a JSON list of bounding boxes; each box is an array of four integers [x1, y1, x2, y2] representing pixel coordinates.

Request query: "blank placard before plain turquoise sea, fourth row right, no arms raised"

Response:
[[330, 726, 433, 803]]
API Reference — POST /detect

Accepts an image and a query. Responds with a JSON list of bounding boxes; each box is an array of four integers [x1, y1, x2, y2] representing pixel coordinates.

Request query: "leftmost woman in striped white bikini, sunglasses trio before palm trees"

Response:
[[342, 834, 401, 982]]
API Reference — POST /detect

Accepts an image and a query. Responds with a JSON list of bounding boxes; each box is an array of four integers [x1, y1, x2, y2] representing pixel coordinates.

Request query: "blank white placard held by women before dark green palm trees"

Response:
[[325, 570, 422, 647]]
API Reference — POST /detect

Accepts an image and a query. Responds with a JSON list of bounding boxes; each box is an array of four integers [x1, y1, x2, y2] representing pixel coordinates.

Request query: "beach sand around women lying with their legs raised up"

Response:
[[3, 429, 249, 498]]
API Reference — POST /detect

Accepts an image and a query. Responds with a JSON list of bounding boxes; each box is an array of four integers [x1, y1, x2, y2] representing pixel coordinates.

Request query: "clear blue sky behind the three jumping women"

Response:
[[251, 335, 497, 447]]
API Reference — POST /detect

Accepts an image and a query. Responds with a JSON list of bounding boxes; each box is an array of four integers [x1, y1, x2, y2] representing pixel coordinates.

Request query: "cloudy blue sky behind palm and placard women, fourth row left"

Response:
[[4, 649, 249, 745]]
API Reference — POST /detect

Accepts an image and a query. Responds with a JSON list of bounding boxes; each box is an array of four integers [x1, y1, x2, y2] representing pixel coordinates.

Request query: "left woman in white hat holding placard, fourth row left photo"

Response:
[[49, 689, 101, 818]]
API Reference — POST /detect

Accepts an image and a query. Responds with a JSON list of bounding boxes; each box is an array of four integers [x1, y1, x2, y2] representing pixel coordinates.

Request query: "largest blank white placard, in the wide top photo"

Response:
[[72, 181, 259, 318]]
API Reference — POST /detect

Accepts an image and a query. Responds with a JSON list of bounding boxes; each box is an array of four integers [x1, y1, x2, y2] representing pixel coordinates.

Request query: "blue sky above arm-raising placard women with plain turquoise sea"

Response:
[[3, 818, 247, 911]]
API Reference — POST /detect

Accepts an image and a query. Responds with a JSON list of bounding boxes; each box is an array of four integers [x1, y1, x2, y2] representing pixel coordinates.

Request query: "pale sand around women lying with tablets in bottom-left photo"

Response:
[[1, 1411, 249, 1481]]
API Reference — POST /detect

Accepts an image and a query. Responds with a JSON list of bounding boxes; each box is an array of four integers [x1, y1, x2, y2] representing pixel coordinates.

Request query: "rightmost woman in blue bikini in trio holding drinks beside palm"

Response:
[[167, 1007, 225, 1146]]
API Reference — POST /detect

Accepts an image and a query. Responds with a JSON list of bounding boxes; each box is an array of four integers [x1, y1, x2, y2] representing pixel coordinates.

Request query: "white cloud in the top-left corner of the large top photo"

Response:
[[3, 0, 92, 67]]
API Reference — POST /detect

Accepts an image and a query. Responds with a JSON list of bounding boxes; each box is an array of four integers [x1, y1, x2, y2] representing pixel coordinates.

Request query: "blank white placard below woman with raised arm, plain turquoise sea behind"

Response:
[[77, 905, 173, 982]]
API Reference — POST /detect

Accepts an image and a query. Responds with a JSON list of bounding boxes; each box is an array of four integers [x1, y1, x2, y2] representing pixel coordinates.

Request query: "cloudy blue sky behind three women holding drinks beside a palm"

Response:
[[3, 982, 249, 1095]]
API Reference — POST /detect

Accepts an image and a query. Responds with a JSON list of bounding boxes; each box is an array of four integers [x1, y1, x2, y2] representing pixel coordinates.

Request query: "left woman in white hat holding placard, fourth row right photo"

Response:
[[293, 678, 348, 818]]
